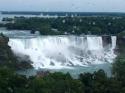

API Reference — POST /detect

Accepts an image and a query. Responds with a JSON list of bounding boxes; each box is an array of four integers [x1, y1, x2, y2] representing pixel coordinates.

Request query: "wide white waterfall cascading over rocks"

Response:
[[9, 36, 117, 69]]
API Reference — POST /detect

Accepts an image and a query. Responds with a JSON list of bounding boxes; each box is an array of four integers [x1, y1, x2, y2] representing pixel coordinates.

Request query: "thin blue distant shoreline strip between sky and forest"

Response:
[[0, 11, 125, 16]]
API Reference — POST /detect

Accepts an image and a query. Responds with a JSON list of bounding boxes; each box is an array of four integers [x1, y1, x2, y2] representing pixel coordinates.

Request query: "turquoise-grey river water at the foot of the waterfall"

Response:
[[17, 63, 112, 78]]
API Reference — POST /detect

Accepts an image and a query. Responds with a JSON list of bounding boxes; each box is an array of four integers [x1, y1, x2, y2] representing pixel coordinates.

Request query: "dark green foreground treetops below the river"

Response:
[[0, 56, 125, 93]]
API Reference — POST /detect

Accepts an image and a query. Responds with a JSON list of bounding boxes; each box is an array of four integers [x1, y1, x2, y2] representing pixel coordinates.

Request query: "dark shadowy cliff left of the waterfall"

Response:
[[0, 34, 32, 69]]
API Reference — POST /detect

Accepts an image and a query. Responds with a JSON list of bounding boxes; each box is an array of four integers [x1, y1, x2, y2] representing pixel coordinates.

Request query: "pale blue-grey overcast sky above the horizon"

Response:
[[0, 0, 125, 12]]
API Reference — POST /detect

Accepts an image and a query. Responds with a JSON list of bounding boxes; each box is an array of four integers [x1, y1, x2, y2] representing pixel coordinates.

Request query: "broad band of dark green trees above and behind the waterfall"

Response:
[[0, 16, 125, 35]]
